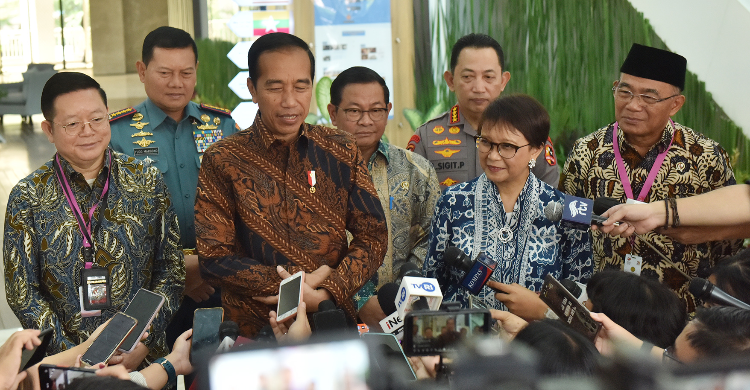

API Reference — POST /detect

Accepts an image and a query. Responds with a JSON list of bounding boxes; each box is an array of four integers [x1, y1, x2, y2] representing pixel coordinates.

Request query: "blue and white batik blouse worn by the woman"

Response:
[[422, 174, 593, 310]]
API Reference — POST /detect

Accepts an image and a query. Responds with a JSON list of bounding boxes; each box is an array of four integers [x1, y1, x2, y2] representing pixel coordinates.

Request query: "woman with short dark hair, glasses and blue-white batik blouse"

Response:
[[423, 95, 593, 319]]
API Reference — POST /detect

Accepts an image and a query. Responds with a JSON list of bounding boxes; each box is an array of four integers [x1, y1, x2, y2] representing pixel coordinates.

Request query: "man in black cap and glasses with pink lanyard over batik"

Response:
[[560, 44, 742, 312]]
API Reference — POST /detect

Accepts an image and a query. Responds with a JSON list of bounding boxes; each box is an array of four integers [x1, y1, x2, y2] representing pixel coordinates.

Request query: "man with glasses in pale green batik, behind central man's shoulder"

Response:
[[328, 66, 440, 329]]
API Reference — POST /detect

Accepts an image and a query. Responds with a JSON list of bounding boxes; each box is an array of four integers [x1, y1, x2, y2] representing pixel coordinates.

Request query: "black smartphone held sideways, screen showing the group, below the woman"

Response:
[[401, 309, 493, 356]]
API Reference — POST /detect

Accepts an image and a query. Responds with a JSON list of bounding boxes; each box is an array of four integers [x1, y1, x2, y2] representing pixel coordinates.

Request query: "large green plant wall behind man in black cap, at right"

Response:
[[415, 0, 750, 181]]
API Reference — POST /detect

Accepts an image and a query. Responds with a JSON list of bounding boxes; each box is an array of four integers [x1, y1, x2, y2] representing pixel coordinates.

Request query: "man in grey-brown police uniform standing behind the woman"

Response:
[[406, 34, 560, 189]]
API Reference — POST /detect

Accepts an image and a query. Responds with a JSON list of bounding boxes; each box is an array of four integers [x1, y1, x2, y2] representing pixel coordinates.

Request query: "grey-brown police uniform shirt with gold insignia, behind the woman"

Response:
[[406, 104, 560, 190]]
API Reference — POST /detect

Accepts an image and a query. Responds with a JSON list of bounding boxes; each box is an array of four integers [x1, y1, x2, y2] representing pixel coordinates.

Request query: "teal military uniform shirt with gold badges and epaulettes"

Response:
[[110, 99, 239, 248]]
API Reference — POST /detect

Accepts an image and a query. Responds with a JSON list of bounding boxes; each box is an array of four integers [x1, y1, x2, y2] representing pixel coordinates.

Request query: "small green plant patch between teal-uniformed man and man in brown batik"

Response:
[[194, 39, 242, 110]]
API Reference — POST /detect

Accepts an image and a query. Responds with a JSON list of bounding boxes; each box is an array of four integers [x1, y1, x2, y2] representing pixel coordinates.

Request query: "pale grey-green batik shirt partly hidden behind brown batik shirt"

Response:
[[354, 141, 440, 309]]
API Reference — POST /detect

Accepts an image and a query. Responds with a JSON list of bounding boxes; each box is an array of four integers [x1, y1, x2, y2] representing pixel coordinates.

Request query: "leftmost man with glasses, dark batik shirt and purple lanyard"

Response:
[[3, 72, 185, 370]]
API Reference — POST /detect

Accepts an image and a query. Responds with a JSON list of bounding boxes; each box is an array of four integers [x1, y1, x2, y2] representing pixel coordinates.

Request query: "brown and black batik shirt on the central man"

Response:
[[195, 113, 388, 336]]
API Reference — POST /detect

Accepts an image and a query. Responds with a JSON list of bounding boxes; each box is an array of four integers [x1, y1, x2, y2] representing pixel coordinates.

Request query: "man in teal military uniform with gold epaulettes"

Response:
[[110, 27, 239, 345]]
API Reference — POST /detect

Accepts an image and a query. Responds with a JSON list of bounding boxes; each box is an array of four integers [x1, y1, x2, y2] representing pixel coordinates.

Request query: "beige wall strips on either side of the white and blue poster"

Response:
[[292, 0, 416, 148]]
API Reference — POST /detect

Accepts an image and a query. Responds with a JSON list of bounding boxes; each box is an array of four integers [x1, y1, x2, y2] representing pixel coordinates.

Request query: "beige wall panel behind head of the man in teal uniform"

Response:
[[89, 0, 193, 76]]
